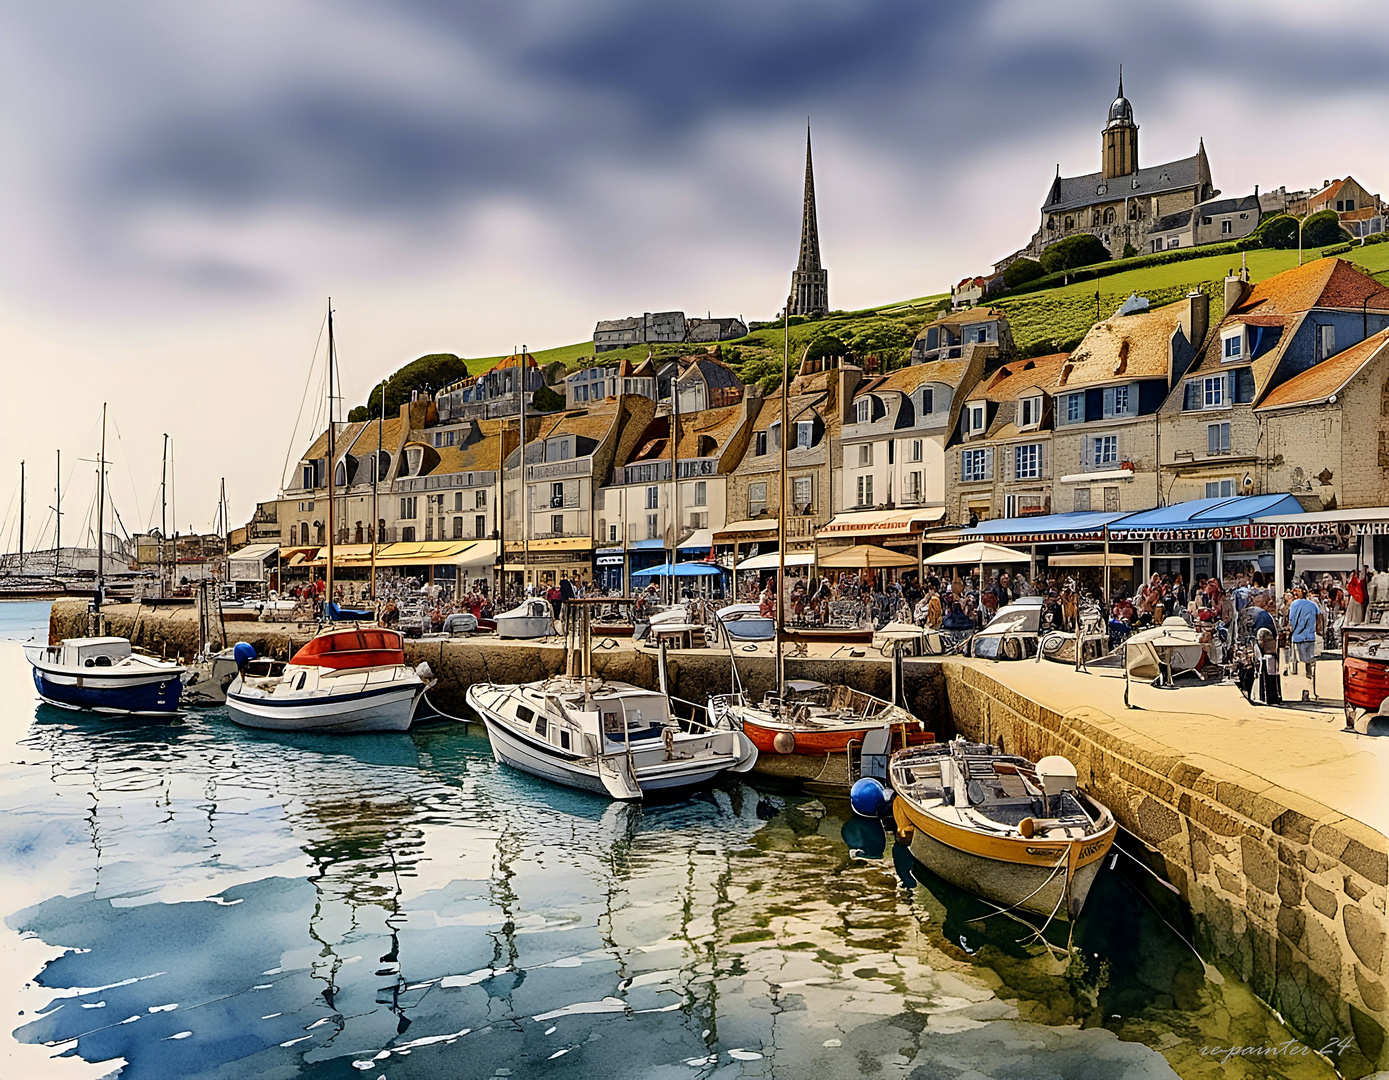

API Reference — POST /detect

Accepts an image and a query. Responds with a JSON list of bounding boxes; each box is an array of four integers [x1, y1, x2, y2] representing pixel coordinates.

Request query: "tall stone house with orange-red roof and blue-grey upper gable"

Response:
[[1158, 258, 1389, 504]]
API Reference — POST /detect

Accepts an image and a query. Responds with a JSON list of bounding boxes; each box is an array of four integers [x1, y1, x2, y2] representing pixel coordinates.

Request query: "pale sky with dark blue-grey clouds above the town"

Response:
[[0, 0, 1389, 550]]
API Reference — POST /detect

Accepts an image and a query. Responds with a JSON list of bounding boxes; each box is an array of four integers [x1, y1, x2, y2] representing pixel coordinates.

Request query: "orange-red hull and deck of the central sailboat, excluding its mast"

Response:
[[708, 679, 931, 757]]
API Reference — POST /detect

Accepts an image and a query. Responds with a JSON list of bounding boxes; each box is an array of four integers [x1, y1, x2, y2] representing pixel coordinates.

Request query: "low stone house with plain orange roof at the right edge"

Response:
[[1254, 329, 1389, 509]]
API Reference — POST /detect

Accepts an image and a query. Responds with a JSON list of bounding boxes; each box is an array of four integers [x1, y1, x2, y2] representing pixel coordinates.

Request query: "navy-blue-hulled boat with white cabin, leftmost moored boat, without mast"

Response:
[[24, 637, 185, 715]]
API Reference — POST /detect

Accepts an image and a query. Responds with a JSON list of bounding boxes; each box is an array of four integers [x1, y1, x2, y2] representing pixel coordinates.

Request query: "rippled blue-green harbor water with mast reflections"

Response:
[[0, 605, 1331, 1080]]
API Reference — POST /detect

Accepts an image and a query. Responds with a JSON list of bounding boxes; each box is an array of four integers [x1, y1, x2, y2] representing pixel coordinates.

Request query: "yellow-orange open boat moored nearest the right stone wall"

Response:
[[888, 739, 1118, 919]]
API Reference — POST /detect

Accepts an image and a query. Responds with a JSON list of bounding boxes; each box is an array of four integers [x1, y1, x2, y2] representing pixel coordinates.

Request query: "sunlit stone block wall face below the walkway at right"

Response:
[[940, 659, 1389, 1076]]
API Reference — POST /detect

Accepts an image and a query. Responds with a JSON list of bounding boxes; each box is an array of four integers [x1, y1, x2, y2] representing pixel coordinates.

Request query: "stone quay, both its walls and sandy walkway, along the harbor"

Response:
[[51, 601, 1389, 1077]]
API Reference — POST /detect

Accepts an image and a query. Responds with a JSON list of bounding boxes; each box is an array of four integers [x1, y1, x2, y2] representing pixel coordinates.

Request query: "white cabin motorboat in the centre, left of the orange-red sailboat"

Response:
[[465, 600, 757, 800]]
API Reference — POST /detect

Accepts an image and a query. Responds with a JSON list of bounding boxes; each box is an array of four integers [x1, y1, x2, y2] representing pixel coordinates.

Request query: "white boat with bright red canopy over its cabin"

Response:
[[226, 625, 435, 733]]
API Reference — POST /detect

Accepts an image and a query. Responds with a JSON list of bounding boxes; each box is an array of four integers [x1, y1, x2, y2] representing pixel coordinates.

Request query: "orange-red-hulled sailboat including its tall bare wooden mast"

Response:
[[708, 300, 932, 777]]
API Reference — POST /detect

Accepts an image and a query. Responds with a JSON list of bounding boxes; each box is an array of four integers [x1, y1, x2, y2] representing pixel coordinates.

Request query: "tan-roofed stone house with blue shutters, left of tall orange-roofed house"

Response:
[[1051, 292, 1210, 514]]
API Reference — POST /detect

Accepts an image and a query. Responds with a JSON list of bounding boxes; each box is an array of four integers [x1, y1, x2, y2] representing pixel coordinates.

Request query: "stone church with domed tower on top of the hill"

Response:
[[1022, 71, 1216, 262]]
